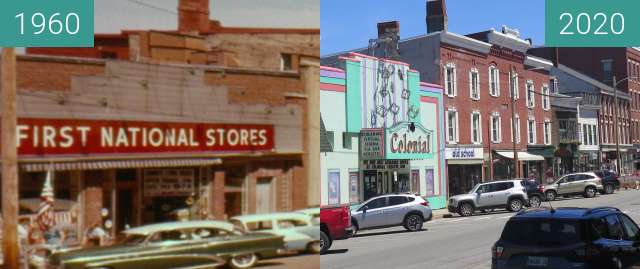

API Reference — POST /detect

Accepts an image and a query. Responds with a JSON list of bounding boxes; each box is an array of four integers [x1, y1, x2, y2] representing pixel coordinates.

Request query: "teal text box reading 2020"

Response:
[[545, 0, 640, 47]]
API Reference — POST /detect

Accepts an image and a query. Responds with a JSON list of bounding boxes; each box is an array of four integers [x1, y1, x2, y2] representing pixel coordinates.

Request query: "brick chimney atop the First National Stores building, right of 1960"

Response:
[[178, 0, 210, 33]]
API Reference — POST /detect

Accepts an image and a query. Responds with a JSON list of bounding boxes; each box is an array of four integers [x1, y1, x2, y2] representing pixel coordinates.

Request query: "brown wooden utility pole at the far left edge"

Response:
[[0, 48, 20, 269]]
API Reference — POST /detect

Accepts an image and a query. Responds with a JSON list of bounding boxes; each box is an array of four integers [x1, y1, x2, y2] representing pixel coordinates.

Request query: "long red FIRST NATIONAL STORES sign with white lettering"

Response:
[[10, 118, 274, 156]]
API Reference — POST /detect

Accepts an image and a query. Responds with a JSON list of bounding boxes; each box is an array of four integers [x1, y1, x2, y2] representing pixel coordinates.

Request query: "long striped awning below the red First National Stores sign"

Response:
[[20, 158, 222, 172]]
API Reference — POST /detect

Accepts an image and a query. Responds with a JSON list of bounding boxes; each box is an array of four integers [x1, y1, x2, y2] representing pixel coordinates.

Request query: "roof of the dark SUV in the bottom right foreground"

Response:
[[511, 207, 620, 220]]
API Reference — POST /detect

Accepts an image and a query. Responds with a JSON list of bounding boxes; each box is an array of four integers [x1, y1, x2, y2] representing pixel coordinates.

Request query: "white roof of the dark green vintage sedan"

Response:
[[123, 220, 233, 235]]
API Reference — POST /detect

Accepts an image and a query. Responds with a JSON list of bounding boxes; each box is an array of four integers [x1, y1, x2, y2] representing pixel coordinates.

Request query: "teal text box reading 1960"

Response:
[[0, 0, 93, 47]]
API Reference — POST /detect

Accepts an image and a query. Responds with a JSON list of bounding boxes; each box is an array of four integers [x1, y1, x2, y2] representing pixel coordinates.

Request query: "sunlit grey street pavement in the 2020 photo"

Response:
[[322, 190, 640, 269]]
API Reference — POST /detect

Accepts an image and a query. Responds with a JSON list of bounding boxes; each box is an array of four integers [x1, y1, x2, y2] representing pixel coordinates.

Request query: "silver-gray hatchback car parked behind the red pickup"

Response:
[[351, 194, 432, 232]]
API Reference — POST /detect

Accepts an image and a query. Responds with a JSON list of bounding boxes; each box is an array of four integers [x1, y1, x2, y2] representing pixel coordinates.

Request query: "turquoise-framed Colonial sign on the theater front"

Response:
[[386, 123, 433, 160]]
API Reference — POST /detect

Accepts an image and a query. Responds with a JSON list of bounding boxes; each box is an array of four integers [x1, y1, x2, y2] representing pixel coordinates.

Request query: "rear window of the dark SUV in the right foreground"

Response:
[[501, 219, 583, 246]]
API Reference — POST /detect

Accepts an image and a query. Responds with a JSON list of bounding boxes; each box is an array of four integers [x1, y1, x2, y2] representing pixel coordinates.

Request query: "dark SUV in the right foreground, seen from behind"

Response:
[[491, 207, 640, 269]]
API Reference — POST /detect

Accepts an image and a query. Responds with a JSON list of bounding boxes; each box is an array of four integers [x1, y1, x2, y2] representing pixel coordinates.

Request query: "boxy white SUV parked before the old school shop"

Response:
[[448, 180, 529, 217]]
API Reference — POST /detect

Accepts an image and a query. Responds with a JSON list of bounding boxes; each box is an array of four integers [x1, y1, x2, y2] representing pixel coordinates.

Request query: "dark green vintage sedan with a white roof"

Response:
[[48, 221, 284, 269]]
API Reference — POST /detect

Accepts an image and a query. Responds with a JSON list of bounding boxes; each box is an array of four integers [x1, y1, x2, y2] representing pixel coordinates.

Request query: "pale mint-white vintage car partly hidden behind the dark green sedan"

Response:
[[229, 213, 322, 253]]
